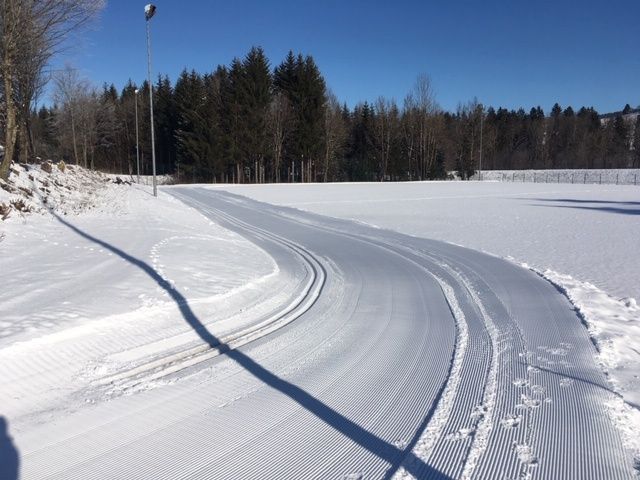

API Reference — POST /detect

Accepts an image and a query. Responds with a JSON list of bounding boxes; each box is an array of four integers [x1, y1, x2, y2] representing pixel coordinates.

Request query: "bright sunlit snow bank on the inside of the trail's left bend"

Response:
[[0, 166, 290, 429]]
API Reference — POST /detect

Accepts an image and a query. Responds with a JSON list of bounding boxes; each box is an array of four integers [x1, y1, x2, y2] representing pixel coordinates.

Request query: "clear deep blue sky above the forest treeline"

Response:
[[58, 0, 640, 113]]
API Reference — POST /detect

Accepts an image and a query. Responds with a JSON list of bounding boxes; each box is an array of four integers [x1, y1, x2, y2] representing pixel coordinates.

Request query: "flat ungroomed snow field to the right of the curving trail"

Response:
[[208, 181, 640, 462]]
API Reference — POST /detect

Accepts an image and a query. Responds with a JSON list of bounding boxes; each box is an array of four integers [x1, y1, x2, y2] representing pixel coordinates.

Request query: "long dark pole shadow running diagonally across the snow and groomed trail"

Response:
[[51, 212, 451, 480]]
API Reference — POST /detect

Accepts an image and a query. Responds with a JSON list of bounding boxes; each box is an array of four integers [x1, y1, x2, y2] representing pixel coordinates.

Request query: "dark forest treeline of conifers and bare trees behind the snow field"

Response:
[[20, 48, 640, 183]]
